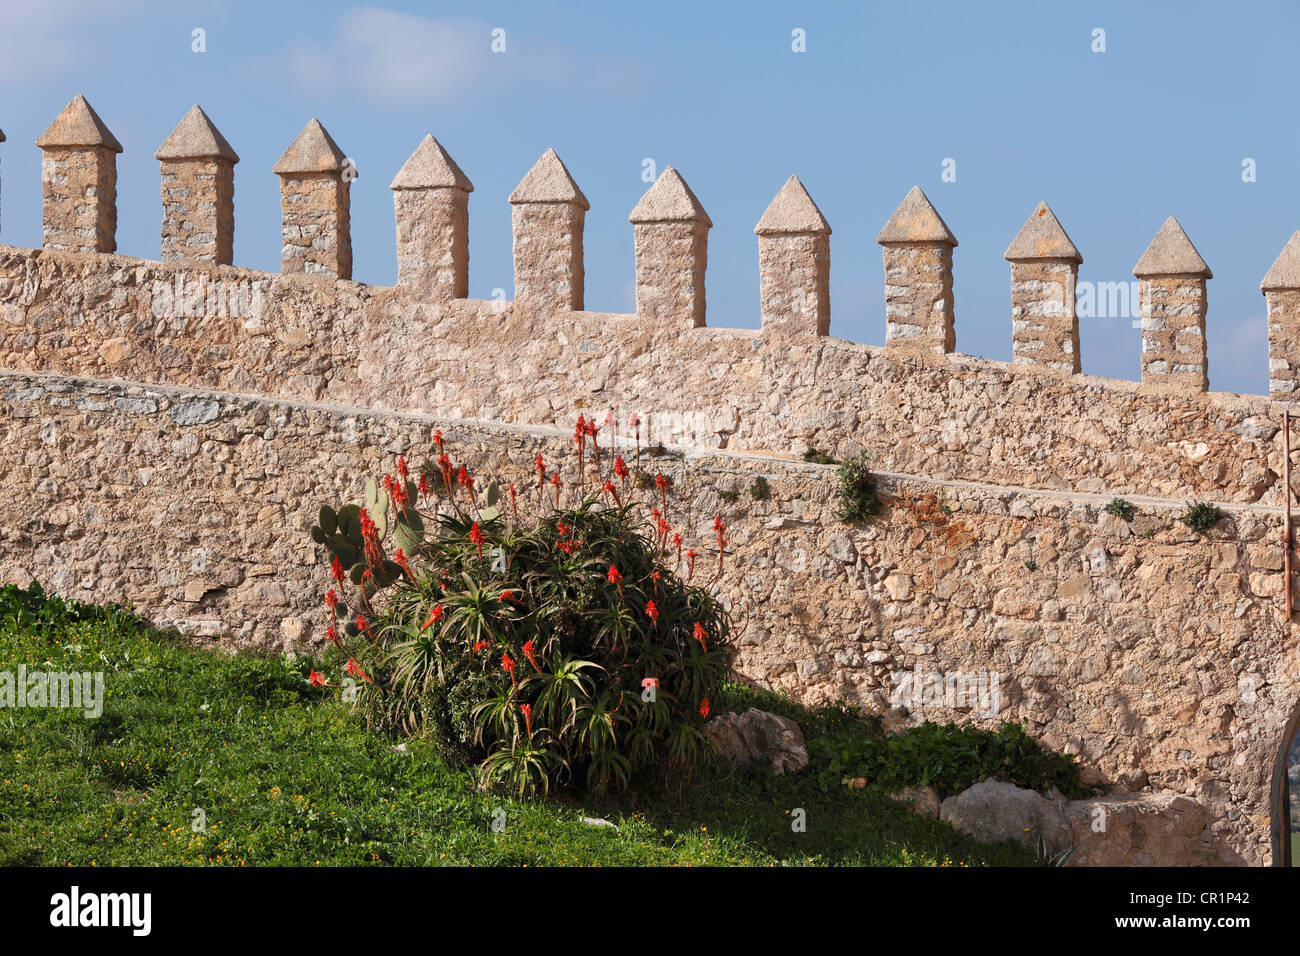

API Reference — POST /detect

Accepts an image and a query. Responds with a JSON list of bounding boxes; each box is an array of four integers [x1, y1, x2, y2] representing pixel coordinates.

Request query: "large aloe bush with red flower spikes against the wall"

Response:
[[304, 418, 732, 793]]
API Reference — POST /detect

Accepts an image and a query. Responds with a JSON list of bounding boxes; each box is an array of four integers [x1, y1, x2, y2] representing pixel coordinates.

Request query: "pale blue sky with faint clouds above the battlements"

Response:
[[0, 0, 1300, 393]]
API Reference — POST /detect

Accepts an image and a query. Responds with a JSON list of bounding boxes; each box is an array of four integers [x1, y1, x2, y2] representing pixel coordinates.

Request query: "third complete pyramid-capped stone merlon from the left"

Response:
[[272, 120, 352, 278]]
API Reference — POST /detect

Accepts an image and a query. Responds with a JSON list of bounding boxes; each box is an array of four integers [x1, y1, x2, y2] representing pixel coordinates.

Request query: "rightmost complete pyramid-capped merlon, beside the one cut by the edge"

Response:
[[1134, 216, 1214, 392]]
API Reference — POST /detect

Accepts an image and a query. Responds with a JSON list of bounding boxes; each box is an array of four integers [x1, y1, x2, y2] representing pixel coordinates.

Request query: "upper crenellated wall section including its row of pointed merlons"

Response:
[[0, 96, 1300, 502]]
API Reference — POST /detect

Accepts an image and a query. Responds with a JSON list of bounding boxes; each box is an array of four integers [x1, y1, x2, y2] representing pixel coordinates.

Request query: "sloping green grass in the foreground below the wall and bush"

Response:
[[0, 589, 1034, 866]]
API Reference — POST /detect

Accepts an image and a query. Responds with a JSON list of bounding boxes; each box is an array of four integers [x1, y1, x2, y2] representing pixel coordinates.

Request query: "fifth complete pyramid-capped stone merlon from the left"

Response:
[[510, 150, 592, 312]]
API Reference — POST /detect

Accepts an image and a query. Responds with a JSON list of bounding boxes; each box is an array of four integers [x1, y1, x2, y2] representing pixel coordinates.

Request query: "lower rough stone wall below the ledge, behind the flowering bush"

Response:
[[0, 372, 1297, 864]]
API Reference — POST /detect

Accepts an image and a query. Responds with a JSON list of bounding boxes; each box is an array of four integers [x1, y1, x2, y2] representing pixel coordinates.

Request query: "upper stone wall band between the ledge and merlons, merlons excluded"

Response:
[[0, 246, 1281, 512]]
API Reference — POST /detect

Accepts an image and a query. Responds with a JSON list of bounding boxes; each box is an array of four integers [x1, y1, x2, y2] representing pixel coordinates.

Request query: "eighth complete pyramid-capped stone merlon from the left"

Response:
[[876, 186, 957, 352]]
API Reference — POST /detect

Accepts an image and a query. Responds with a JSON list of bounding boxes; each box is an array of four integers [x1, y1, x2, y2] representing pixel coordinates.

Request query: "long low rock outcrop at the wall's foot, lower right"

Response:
[[939, 778, 1216, 866]]
